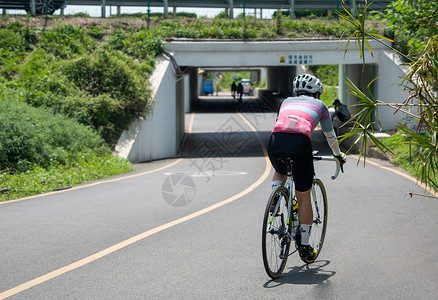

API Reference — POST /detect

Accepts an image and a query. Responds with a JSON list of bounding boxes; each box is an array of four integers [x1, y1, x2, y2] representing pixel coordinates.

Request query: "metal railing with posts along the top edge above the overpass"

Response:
[[0, 0, 392, 19]]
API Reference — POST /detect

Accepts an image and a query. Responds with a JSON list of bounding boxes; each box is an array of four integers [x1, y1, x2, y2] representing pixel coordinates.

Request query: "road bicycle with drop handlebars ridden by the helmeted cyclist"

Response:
[[262, 151, 343, 279]]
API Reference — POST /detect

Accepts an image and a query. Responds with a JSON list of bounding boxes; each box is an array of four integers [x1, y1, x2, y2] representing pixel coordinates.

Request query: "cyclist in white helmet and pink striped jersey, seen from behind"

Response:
[[268, 74, 346, 263]]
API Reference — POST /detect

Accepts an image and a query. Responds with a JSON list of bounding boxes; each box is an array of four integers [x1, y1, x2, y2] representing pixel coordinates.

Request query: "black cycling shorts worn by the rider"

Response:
[[268, 132, 314, 192]]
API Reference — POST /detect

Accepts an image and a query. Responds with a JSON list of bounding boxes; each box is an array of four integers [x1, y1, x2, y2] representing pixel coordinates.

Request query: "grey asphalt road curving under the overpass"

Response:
[[0, 98, 438, 299]]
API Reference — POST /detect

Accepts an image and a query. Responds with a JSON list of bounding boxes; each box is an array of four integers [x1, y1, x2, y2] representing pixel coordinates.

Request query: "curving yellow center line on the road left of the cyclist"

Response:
[[0, 113, 271, 299]]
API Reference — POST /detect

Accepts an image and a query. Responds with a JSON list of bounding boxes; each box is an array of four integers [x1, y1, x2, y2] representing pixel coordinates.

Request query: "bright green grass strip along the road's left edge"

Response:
[[0, 155, 132, 202]]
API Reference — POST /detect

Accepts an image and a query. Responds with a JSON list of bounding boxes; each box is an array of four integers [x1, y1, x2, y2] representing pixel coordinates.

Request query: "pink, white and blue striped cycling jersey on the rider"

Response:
[[272, 95, 333, 138]]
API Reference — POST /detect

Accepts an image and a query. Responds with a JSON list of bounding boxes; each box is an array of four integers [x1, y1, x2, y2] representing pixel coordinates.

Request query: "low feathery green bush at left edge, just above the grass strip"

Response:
[[0, 98, 109, 173]]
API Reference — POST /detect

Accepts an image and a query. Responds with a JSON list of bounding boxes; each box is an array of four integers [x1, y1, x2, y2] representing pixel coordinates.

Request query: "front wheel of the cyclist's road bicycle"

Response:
[[309, 179, 328, 259]]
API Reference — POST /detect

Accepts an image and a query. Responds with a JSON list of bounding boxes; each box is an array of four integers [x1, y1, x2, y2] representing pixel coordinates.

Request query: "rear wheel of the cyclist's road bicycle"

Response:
[[262, 186, 291, 279]]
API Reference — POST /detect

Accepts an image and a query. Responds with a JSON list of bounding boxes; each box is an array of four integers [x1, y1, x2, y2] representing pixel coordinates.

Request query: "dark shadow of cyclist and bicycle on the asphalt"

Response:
[[263, 260, 336, 288]]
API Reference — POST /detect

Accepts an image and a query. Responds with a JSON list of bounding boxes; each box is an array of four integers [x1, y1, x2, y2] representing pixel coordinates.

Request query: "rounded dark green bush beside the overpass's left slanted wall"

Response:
[[62, 52, 151, 144]]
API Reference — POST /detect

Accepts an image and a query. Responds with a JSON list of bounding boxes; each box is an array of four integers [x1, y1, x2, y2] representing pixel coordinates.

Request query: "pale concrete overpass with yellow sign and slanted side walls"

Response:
[[116, 39, 408, 162]]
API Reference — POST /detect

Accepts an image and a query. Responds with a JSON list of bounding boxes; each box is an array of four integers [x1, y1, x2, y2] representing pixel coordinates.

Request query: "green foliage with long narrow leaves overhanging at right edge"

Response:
[[338, 0, 438, 190]]
